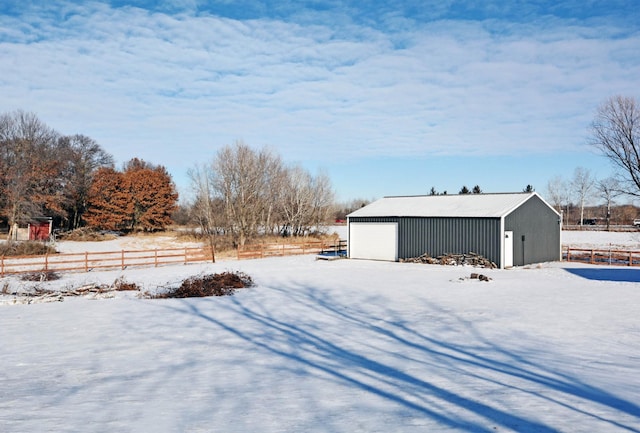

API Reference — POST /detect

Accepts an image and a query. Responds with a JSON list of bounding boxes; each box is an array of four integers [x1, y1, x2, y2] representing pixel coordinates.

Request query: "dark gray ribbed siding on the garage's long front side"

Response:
[[349, 217, 502, 266]]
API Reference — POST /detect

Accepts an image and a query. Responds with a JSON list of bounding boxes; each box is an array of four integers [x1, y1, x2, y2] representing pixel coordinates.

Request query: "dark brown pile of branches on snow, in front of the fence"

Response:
[[153, 272, 253, 299]]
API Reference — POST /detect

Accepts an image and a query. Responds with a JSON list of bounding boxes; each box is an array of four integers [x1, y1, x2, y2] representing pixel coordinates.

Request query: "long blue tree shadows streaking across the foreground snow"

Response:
[[161, 278, 640, 433]]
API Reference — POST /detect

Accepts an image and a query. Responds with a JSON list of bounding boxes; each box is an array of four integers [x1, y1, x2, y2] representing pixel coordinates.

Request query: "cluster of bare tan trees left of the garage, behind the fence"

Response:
[[189, 142, 335, 245]]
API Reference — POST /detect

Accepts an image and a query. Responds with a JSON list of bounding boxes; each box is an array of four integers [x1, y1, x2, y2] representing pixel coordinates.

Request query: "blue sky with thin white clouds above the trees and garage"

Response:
[[0, 0, 640, 200]]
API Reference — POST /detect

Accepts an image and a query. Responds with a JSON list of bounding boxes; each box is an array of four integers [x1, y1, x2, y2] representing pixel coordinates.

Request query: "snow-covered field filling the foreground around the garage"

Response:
[[0, 228, 640, 433]]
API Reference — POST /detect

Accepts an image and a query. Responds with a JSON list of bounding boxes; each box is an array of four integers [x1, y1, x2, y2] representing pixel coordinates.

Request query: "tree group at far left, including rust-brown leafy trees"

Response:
[[0, 110, 178, 239]]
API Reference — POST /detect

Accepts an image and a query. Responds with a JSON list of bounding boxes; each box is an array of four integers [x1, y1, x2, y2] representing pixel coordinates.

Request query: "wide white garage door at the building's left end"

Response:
[[348, 223, 398, 262]]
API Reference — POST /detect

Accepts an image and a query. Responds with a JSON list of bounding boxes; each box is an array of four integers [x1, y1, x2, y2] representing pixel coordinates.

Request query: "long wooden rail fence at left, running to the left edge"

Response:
[[0, 248, 214, 276]]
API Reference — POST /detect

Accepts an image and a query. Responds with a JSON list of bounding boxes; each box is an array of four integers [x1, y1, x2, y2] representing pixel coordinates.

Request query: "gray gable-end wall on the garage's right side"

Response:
[[504, 196, 561, 266]]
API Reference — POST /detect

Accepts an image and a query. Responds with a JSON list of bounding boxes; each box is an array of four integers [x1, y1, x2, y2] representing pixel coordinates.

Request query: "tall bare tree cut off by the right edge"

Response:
[[590, 96, 640, 196]]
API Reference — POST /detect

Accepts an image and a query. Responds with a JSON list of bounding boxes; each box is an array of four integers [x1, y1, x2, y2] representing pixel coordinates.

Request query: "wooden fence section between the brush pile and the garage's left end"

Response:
[[237, 240, 347, 260]]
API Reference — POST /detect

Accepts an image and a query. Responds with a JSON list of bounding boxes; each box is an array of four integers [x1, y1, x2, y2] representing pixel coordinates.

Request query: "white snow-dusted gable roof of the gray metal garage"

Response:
[[347, 192, 557, 218]]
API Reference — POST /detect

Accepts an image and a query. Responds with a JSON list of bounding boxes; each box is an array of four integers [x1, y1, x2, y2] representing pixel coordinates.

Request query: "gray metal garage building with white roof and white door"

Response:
[[347, 192, 562, 268]]
